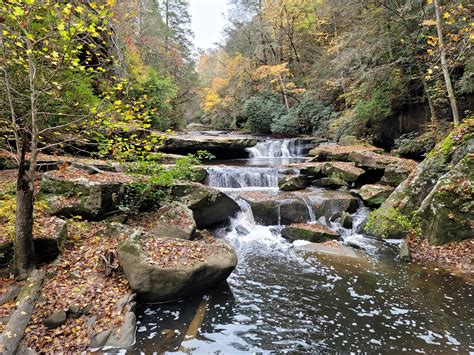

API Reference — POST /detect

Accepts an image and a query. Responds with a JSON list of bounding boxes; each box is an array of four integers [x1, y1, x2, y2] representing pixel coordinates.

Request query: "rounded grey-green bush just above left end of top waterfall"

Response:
[[244, 95, 285, 133]]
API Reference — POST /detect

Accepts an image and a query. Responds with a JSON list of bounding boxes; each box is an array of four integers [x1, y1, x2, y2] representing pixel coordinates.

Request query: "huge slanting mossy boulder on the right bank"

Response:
[[367, 120, 474, 244]]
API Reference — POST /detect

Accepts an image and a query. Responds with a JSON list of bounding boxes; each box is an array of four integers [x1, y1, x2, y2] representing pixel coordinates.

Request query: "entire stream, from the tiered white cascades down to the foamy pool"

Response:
[[130, 139, 474, 354]]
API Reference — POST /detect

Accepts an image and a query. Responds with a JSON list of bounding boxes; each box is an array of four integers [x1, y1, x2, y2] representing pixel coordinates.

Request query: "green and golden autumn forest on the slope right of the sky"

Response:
[[199, 0, 474, 139]]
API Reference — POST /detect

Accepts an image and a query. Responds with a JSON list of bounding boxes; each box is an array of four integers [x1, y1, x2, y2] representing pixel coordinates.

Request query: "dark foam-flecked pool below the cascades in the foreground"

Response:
[[135, 231, 474, 354]]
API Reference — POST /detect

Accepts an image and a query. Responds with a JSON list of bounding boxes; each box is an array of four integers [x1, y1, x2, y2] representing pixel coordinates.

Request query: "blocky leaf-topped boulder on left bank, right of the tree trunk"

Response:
[[41, 169, 134, 220]]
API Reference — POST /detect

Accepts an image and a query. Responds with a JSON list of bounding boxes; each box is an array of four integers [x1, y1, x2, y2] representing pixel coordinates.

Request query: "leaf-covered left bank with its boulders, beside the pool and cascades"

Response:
[[0, 157, 239, 352]]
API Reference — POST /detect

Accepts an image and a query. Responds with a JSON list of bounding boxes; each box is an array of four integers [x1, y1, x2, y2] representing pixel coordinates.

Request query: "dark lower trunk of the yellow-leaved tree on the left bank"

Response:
[[14, 138, 35, 277]]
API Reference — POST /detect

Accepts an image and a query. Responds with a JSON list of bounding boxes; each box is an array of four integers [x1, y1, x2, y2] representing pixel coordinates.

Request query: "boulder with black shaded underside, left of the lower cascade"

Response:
[[171, 182, 240, 229]]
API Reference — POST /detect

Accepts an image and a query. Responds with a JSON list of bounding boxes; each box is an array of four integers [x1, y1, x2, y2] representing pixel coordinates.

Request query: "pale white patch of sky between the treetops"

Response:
[[190, 0, 227, 49]]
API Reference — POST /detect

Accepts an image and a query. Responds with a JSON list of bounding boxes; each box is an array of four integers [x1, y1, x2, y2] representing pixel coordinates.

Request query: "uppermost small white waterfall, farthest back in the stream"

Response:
[[247, 138, 307, 159]]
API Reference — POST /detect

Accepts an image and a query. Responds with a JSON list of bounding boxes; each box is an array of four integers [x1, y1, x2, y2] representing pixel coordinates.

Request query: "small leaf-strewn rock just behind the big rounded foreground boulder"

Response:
[[150, 202, 196, 240]]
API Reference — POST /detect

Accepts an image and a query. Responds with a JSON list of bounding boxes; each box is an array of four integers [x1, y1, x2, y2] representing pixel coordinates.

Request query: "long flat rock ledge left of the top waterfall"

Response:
[[158, 136, 258, 158]]
